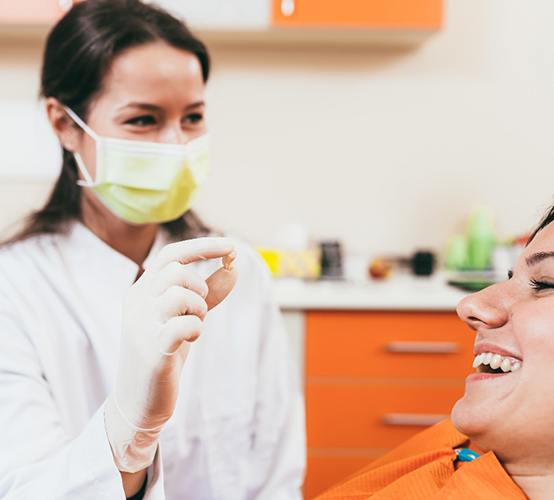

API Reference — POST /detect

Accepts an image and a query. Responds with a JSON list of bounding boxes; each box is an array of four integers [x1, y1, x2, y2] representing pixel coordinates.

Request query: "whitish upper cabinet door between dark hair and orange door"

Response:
[[157, 0, 271, 30]]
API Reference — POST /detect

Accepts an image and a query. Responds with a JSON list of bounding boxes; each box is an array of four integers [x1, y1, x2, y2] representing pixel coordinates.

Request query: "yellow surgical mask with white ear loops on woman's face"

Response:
[[65, 107, 209, 224]]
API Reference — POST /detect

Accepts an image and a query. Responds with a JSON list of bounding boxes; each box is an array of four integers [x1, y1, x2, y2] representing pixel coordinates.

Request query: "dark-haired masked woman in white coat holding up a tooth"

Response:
[[0, 0, 305, 500]]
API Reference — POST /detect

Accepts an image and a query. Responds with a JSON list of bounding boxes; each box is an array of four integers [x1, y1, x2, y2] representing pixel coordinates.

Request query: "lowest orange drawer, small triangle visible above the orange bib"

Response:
[[304, 451, 378, 500]]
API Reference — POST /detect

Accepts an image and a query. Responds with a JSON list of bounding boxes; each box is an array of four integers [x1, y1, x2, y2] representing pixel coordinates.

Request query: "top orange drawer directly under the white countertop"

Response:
[[306, 312, 474, 379]]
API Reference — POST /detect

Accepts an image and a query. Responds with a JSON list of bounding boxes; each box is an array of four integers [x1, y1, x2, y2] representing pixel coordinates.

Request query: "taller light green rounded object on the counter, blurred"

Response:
[[467, 209, 496, 269]]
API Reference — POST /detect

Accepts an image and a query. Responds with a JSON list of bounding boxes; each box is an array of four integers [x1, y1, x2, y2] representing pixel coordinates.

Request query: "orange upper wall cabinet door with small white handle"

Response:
[[272, 0, 442, 30]]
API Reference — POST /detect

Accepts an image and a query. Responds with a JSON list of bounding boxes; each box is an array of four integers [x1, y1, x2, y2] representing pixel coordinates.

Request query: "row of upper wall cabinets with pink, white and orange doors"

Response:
[[0, 0, 444, 45]]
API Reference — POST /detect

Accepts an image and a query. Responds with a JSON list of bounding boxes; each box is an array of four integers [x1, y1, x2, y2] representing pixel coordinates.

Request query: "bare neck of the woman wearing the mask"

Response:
[[81, 196, 158, 266]]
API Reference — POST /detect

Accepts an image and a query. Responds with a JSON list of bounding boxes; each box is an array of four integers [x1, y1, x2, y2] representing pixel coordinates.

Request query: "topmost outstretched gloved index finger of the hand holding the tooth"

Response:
[[150, 238, 234, 271]]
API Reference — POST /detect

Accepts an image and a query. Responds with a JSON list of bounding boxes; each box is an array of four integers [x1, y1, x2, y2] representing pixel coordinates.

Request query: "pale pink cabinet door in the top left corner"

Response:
[[0, 0, 73, 25]]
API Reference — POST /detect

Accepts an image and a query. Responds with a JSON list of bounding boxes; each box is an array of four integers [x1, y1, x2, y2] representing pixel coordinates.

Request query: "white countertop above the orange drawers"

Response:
[[275, 273, 468, 311]]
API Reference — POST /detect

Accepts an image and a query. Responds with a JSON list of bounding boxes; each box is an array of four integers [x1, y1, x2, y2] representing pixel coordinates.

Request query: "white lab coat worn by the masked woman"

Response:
[[0, 223, 305, 500]]
